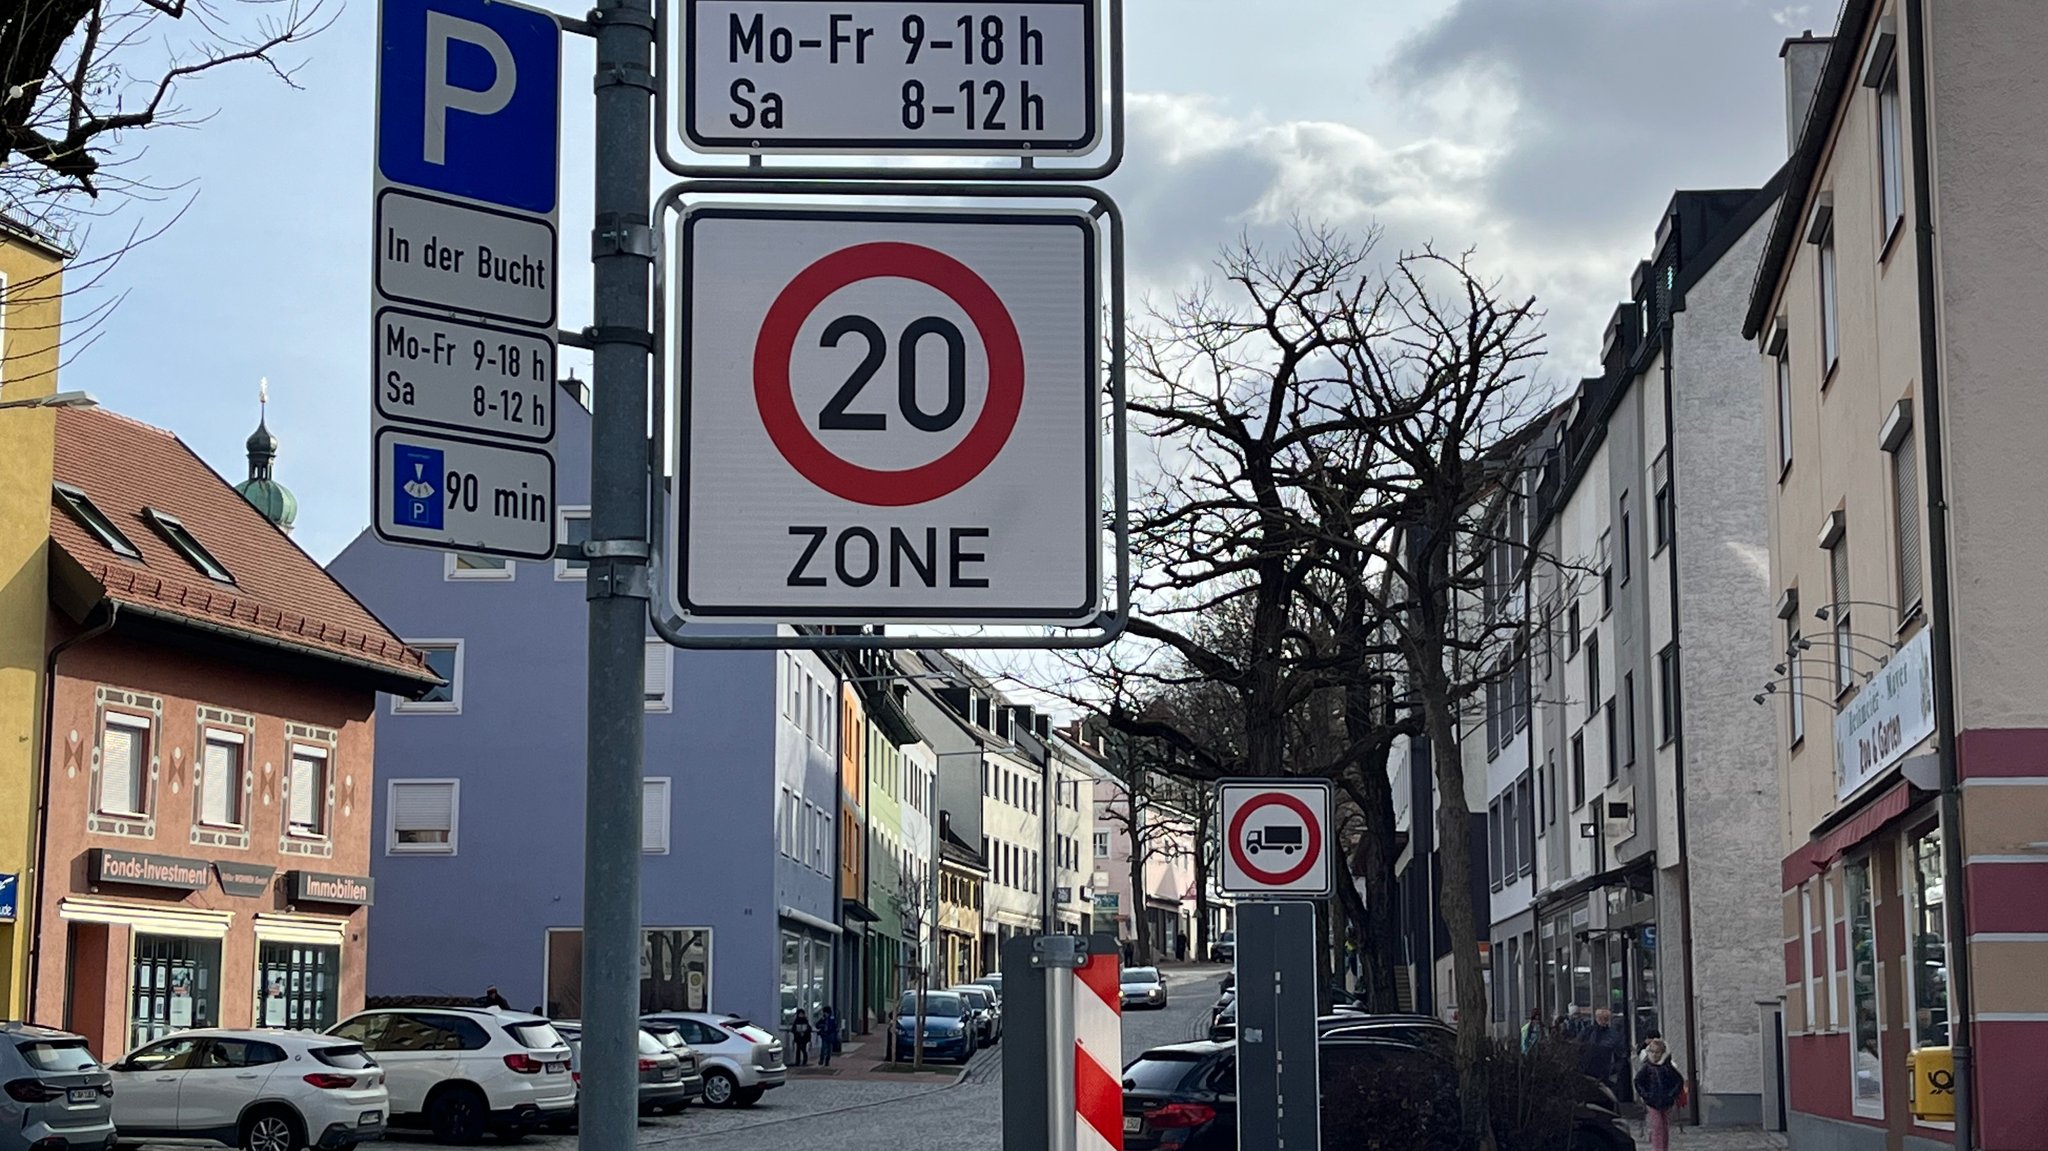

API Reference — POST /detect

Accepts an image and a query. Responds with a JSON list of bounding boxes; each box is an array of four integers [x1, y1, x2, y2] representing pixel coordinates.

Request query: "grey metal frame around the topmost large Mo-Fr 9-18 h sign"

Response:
[[684, 0, 1120, 158]]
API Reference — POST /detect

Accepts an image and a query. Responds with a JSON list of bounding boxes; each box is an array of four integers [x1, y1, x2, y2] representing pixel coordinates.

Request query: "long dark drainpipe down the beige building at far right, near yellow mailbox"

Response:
[[1905, 0, 1976, 1151]]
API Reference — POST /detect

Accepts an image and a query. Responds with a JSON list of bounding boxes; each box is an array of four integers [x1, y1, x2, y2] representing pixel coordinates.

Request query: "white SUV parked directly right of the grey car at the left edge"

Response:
[[106, 1030, 389, 1151]]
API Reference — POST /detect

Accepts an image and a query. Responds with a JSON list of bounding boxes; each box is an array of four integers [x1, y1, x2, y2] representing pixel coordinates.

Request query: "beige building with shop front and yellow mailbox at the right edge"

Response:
[[1745, 0, 2048, 1151]]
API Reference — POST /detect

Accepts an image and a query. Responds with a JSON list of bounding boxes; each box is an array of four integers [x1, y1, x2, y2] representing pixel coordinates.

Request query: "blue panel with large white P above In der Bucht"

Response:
[[377, 0, 561, 215]]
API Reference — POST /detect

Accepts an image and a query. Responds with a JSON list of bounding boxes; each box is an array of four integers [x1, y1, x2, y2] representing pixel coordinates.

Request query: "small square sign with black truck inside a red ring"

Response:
[[1217, 778, 1333, 895]]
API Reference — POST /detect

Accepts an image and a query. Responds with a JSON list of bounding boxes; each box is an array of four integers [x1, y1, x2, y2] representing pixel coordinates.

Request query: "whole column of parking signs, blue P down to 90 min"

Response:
[[369, 0, 565, 559]]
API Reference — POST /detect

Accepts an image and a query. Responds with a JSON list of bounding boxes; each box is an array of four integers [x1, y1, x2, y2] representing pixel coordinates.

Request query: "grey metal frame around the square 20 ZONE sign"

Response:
[[657, 198, 1128, 626]]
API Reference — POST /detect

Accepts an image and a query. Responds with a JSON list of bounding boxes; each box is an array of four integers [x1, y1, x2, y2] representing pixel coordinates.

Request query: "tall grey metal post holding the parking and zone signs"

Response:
[[580, 0, 653, 1151]]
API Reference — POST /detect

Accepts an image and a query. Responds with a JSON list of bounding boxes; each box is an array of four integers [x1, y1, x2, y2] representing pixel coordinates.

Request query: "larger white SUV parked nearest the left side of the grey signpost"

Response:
[[328, 1008, 575, 1143]]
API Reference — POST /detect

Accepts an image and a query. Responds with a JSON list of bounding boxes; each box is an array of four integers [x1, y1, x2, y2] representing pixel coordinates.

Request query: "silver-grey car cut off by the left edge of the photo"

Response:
[[0, 1022, 115, 1151]]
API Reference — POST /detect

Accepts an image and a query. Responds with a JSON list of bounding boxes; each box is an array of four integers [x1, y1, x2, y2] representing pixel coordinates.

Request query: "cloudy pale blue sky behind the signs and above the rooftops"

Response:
[[51, 0, 1810, 559]]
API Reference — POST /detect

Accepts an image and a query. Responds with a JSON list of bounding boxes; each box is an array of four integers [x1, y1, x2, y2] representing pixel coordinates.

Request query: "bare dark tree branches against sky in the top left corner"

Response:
[[0, 0, 332, 217]]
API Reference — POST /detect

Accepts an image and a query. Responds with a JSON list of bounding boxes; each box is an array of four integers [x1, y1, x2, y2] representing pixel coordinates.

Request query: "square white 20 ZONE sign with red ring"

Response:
[[672, 203, 1104, 625]]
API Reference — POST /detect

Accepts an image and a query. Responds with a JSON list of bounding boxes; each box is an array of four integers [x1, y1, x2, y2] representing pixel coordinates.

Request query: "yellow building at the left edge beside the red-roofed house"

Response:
[[0, 217, 68, 1020]]
